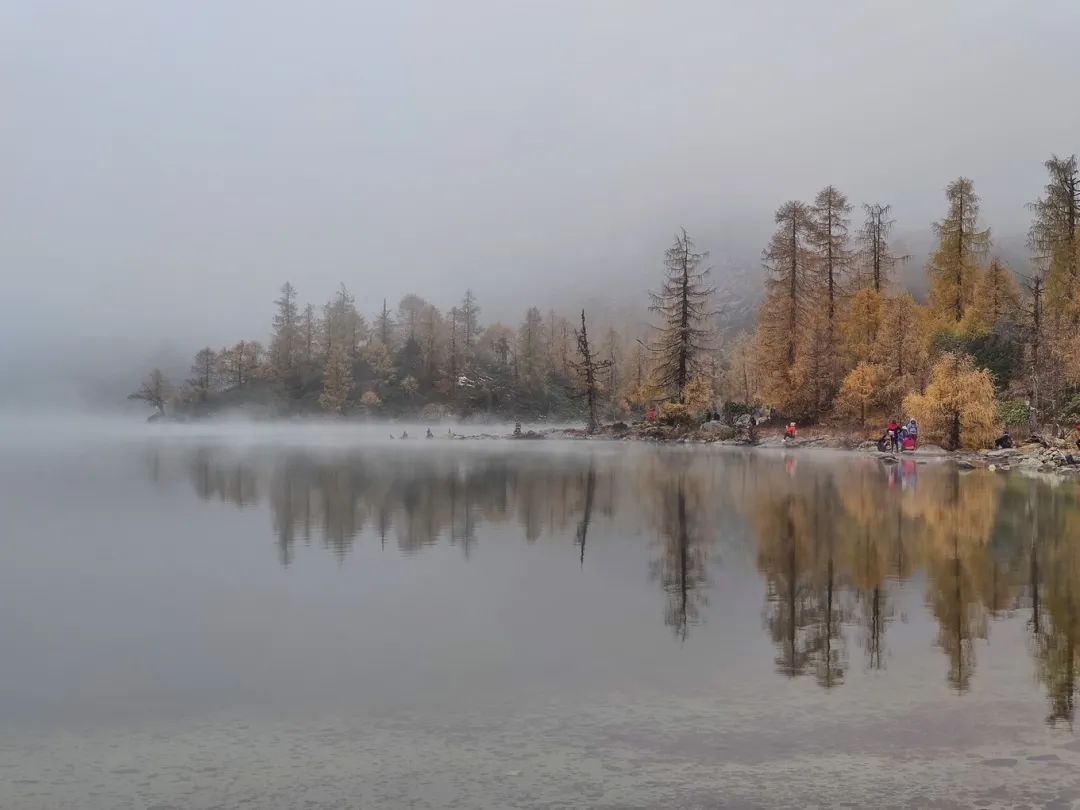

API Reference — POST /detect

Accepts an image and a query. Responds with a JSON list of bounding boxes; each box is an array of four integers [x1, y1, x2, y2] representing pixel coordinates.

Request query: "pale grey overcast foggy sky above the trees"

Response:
[[0, 0, 1080, 367]]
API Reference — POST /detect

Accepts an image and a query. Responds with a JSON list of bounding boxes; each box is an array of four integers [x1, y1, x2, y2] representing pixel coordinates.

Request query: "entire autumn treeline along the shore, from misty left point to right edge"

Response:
[[132, 157, 1080, 447]]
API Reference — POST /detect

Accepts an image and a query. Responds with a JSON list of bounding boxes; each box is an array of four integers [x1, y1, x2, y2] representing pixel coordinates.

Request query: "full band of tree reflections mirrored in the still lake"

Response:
[[147, 447, 1080, 725]]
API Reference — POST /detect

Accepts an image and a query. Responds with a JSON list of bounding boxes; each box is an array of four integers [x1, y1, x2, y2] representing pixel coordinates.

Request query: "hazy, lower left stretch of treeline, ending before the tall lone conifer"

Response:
[[132, 283, 647, 421]]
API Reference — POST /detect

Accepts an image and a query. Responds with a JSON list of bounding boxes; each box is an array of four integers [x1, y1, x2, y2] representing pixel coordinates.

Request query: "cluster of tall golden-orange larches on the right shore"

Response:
[[751, 157, 1080, 447]]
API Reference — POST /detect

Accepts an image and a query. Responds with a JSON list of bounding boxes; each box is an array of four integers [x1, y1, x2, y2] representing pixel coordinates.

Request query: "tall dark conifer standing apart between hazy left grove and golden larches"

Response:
[[649, 229, 714, 401]]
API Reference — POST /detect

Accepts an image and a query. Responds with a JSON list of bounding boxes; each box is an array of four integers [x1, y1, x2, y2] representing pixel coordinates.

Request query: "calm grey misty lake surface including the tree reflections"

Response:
[[6, 426, 1080, 810]]
